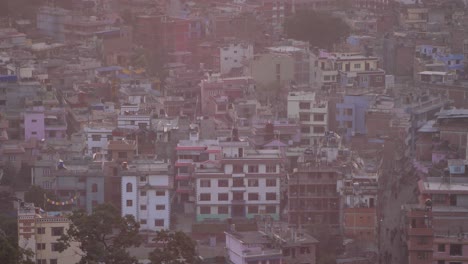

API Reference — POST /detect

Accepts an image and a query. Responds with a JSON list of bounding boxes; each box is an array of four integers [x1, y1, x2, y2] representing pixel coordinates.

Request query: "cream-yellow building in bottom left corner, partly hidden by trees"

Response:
[[18, 203, 82, 264]]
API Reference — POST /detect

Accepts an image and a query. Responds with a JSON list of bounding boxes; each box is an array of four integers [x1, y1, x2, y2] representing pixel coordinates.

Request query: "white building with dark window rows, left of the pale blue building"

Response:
[[287, 92, 328, 144]]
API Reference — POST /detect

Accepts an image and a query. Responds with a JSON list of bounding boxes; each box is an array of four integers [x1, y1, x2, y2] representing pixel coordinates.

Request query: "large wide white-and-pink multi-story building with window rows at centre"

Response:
[[195, 141, 285, 221]]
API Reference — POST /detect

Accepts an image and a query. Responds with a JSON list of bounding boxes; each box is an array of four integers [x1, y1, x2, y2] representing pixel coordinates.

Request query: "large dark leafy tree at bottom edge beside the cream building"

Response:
[[59, 204, 141, 264]]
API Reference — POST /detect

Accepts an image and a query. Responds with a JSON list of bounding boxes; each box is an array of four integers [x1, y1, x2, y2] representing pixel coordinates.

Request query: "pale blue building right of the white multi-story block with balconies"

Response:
[[336, 95, 373, 139]]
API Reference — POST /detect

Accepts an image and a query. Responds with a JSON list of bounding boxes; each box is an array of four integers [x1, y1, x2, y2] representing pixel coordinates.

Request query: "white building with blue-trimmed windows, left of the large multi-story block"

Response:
[[121, 160, 173, 231]]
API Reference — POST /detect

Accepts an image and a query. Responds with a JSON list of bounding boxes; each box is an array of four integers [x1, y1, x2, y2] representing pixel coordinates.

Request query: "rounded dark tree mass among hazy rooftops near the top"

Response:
[[284, 11, 351, 49]]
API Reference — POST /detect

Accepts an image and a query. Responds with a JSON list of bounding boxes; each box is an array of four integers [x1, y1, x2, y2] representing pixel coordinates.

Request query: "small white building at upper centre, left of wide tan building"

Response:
[[219, 43, 253, 74]]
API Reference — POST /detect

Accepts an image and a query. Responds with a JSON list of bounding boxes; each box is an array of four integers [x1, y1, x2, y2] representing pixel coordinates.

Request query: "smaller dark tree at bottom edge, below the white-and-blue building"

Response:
[[150, 230, 199, 264]]
